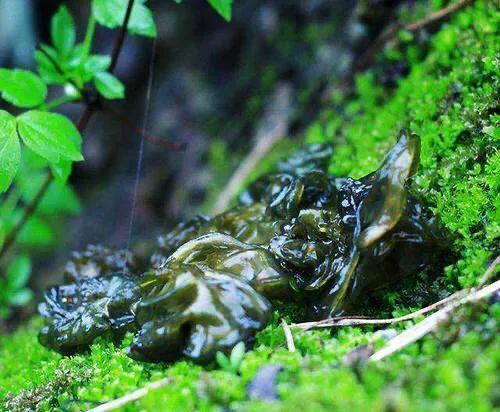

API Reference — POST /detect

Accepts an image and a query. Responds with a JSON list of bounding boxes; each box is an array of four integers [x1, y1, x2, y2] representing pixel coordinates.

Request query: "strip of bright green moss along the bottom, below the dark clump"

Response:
[[0, 304, 500, 411]]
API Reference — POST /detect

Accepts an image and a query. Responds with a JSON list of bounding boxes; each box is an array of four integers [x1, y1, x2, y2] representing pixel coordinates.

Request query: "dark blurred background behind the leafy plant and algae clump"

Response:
[[0, 0, 418, 326]]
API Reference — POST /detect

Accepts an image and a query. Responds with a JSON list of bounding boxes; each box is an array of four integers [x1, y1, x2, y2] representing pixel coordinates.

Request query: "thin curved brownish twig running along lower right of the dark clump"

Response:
[[292, 290, 467, 330]]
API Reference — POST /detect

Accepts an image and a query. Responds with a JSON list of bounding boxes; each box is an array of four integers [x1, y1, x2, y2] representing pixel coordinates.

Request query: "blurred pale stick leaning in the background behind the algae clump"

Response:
[[211, 85, 291, 214]]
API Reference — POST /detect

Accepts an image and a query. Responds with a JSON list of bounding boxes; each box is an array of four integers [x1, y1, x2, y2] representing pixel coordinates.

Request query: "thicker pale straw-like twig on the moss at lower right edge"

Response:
[[369, 280, 500, 361]]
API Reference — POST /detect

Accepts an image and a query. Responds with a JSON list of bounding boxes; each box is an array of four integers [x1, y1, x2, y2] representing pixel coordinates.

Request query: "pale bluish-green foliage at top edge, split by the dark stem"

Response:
[[92, 0, 156, 37]]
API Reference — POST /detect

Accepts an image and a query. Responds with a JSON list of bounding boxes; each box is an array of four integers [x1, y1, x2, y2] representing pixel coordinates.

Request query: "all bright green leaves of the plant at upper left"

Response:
[[0, 0, 160, 315]]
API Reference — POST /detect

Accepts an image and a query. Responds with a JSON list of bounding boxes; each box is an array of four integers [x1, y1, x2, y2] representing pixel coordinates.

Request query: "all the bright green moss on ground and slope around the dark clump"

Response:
[[0, 1, 500, 411]]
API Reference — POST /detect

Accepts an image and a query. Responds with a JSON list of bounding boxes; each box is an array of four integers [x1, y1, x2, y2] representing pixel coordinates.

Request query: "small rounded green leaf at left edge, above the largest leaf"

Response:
[[0, 69, 47, 108]]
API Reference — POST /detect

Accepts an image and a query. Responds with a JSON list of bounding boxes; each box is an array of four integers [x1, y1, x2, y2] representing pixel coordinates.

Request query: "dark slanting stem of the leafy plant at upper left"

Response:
[[0, 0, 134, 259]]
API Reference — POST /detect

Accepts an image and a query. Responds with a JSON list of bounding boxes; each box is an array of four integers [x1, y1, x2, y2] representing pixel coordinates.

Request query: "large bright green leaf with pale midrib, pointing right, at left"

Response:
[[17, 110, 83, 163]]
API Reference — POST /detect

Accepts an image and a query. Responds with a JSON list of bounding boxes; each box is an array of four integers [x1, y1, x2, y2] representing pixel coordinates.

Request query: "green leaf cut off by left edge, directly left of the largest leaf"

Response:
[[0, 110, 21, 193]]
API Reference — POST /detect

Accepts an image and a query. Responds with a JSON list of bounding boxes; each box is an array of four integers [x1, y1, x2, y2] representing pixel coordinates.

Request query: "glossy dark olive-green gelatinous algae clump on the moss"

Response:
[[39, 132, 436, 363]]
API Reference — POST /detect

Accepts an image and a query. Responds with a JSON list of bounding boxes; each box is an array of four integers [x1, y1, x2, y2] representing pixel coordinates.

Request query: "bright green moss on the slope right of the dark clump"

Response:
[[308, 2, 500, 287]]
